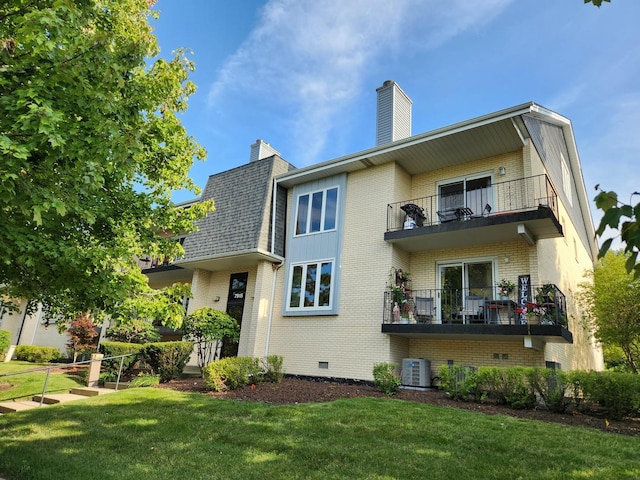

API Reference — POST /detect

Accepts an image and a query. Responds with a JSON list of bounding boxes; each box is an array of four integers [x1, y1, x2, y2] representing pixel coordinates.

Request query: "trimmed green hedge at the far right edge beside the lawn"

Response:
[[570, 372, 640, 420]]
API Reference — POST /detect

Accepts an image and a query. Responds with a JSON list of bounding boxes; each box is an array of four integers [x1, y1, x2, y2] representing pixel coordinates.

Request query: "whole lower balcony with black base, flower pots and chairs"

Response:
[[382, 284, 573, 348]]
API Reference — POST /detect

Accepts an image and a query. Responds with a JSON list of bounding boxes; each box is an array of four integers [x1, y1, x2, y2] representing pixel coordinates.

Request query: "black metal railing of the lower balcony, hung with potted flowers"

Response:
[[382, 283, 567, 327]]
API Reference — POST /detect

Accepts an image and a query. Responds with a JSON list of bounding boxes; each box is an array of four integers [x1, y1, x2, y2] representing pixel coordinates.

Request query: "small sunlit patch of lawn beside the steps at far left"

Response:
[[0, 361, 82, 402]]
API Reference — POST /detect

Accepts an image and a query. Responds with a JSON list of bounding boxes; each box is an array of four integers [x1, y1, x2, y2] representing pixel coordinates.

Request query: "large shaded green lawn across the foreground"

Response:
[[0, 388, 640, 480]]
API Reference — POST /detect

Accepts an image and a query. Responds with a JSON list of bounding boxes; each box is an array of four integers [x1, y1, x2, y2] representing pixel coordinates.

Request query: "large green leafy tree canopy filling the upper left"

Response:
[[0, 0, 212, 316]]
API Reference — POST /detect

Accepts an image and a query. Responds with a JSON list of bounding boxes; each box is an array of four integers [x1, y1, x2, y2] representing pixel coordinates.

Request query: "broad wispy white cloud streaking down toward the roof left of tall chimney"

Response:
[[209, 0, 512, 166]]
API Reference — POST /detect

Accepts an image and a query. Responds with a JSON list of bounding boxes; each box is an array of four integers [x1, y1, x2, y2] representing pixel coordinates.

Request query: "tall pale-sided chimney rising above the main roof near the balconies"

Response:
[[376, 80, 413, 145]]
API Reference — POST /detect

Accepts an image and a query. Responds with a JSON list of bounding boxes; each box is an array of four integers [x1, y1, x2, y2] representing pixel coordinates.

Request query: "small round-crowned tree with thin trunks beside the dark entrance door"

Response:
[[182, 307, 240, 369]]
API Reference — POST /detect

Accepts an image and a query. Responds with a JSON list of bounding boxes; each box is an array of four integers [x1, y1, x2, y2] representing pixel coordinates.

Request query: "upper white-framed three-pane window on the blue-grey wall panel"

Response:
[[295, 187, 338, 235]]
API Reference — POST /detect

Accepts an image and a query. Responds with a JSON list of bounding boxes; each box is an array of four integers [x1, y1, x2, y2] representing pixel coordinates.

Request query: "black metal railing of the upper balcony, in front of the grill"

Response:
[[387, 175, 558, 232]]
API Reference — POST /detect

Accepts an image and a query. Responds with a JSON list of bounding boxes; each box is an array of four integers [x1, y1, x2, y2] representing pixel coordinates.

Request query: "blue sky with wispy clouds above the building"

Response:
[[152, 0, 640, 240]]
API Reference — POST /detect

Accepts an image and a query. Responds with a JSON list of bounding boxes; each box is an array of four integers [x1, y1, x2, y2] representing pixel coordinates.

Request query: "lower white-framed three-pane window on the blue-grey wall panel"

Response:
[[287, 260, 334, 311]]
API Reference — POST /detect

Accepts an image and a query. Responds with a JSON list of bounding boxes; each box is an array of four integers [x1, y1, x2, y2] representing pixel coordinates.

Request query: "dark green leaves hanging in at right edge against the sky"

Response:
[[595, 185, 640, 279]]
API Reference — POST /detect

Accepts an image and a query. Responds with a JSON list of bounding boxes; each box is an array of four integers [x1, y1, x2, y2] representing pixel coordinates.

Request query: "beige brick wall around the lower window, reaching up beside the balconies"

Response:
[[269, 164, 411, 379]]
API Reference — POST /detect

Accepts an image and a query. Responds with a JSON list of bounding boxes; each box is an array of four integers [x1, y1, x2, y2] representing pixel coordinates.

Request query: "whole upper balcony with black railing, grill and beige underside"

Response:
[[384, 175, 563, 252]]
